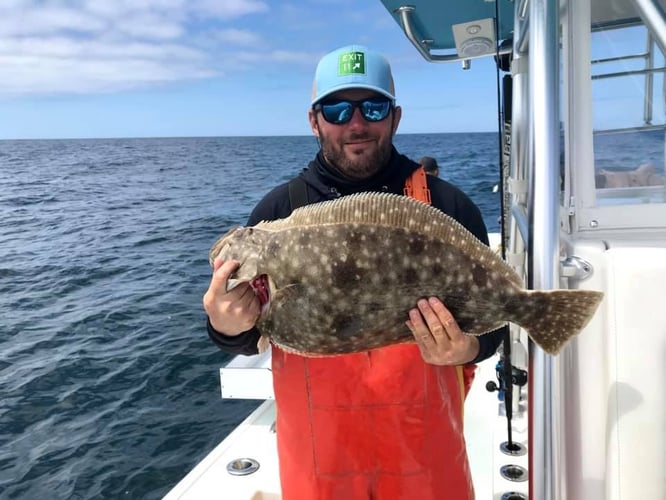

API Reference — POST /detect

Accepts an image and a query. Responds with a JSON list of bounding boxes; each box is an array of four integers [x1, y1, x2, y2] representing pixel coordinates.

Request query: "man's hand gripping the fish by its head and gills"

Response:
[[203, 259, 261, 336]]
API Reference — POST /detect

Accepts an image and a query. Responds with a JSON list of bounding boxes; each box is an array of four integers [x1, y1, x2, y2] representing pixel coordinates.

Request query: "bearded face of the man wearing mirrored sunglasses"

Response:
[[308, 89, 401, 179]]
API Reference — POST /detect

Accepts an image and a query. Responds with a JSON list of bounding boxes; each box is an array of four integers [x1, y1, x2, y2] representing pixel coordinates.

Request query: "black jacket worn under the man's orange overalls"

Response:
[[208, 148, 503, 363]]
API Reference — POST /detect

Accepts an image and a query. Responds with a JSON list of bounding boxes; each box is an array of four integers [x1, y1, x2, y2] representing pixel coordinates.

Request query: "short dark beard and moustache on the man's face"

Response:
[[319, 134, 391, 179]]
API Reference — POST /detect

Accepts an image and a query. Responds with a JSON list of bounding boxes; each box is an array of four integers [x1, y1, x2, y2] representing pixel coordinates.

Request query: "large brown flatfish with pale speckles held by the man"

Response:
[[210, 193, 603, 356]]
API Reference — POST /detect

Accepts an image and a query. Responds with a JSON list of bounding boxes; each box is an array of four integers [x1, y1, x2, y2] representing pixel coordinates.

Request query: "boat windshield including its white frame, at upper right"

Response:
[[560, 0, 666, 232]]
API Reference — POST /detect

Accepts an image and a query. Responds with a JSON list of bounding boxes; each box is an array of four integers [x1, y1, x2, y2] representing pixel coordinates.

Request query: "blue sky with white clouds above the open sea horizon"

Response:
[[0, 0, 497, 139]]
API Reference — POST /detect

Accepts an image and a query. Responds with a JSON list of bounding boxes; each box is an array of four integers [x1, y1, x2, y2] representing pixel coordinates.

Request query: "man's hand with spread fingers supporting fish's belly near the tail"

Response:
[[406, 297, 479, 365]]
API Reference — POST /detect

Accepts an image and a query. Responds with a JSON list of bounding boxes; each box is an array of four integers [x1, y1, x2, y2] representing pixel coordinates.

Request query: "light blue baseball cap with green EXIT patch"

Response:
[[312, 45, 395, 105]]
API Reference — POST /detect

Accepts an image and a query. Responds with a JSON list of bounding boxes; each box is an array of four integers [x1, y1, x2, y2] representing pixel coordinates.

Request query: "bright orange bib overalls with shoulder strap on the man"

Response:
[[272, 168, 474, 500]]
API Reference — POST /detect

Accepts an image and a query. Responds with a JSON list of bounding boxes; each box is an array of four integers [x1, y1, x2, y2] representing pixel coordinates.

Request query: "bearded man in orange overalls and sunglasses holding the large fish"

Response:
[[204, 46, 501, 500]]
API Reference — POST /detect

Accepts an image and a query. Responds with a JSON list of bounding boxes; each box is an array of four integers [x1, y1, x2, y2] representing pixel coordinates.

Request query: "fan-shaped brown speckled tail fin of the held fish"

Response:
[[509, 290, 604, 355]]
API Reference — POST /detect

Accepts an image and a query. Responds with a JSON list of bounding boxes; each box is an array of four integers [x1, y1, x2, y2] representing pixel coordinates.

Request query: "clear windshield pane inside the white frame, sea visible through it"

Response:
[[591, 23, 666, 205]]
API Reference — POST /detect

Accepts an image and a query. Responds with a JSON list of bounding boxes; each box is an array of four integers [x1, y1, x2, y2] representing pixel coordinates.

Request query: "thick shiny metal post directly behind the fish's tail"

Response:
[[528, 0, 566, 500]]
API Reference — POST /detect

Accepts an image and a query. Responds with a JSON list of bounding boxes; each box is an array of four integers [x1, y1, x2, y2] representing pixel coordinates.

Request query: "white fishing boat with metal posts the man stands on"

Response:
[[164, 0, 666, 500]]
